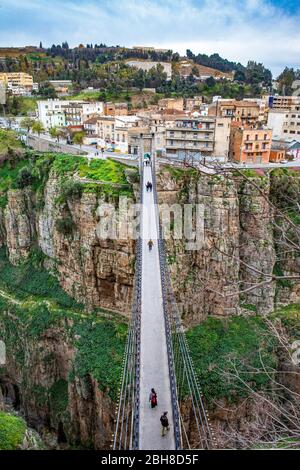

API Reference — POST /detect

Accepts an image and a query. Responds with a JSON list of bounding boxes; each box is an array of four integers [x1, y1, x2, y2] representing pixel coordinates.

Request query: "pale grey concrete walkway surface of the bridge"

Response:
[[139, 163, 175, 450]]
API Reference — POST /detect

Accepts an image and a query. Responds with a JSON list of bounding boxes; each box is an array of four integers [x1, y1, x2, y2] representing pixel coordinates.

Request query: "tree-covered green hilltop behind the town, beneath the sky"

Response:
[[0, 43, 272, 109]]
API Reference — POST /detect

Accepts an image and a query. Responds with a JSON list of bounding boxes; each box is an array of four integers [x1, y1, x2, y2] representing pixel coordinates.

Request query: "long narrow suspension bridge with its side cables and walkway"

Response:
[[113, 155, 215, 450]]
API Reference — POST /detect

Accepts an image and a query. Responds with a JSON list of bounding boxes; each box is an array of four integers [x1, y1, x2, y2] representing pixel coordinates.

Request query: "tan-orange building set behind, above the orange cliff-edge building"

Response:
[[208, 99, 262, 125]]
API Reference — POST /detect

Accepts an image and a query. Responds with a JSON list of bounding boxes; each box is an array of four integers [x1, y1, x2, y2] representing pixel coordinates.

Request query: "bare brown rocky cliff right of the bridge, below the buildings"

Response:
[[157, 167, 300, 326]]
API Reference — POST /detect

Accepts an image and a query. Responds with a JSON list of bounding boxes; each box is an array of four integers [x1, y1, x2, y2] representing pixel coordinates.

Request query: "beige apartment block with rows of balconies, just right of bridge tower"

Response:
[[166, 116, 230, 161]]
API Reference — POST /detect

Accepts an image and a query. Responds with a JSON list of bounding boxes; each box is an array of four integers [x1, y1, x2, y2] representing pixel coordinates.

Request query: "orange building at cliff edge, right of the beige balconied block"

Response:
[[229, 122, 273, 163]]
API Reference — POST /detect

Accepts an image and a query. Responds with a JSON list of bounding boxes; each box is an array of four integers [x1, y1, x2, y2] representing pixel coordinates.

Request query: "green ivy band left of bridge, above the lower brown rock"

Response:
[[0, 247, 127, 400]]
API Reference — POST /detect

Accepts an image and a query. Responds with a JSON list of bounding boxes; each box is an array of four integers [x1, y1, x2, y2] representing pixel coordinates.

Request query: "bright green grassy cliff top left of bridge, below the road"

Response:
[[0, 130, 136, 207]]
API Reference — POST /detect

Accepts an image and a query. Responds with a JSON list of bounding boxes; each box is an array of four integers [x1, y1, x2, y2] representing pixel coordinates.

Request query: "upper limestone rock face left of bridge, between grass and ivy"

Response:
[[0, 177, 135, 314]]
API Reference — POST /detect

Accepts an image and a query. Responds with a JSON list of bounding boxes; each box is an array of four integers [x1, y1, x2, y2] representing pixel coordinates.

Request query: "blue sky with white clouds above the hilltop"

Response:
[[0, 0, 300, 75]]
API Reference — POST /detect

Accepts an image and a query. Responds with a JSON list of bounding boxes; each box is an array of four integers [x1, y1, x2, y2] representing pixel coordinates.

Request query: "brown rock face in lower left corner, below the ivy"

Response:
[[0, 320, 115, 449]]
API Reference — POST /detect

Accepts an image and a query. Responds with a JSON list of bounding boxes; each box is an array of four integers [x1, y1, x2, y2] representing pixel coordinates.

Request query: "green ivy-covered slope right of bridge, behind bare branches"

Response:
[[187, 304, 300, 407]]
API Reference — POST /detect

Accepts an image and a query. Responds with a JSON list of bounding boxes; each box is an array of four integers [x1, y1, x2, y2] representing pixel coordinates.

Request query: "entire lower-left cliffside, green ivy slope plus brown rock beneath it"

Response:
[[0, 248, 127, 448]]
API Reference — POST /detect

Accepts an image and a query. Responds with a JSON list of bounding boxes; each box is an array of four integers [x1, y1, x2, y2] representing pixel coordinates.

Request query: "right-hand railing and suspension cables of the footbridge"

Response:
[[152, 156, 215, 449]]
